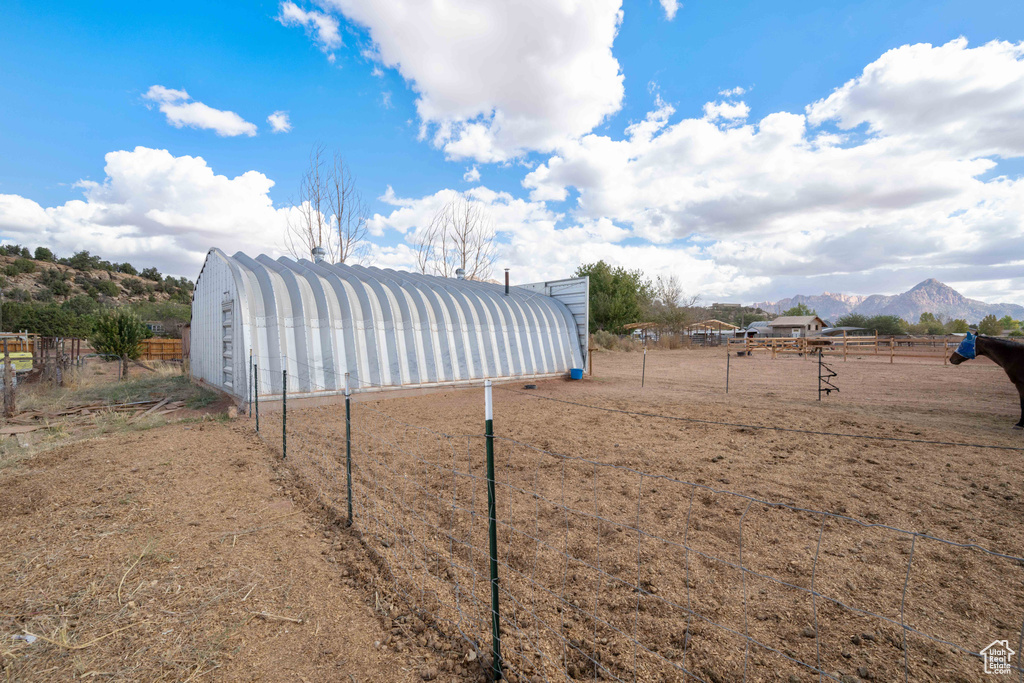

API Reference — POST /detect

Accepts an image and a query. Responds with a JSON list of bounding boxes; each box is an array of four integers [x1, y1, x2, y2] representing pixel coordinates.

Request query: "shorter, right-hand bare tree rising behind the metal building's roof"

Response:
[[414, 194, 498, 280]]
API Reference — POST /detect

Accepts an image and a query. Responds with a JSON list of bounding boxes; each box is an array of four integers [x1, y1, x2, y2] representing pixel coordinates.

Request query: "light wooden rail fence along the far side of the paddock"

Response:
[[727, 335, 964, 362]]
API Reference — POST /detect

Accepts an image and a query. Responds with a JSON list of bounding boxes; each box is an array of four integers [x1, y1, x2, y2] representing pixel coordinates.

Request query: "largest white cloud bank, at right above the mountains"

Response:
[[523, 41, 1024, 297]]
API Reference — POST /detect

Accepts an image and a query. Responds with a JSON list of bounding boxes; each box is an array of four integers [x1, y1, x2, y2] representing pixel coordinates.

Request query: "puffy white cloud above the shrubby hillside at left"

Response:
[[0, 147, 292, 279]]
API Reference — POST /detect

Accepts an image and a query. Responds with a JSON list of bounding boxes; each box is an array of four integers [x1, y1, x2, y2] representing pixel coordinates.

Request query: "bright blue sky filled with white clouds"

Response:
[[0, 0, 1024, 301]]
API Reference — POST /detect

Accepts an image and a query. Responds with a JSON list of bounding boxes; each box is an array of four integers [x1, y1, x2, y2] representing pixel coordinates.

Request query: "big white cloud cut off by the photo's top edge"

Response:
[[283, 0, 624, 162]]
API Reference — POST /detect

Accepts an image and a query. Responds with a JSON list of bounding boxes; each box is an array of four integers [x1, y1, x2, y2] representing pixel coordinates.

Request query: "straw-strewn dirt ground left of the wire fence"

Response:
[[0, 421, 448, 682]]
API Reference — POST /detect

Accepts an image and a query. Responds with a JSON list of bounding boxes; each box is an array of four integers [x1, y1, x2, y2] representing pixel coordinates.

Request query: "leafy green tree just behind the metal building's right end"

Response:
[[575, 261, 652, 334]]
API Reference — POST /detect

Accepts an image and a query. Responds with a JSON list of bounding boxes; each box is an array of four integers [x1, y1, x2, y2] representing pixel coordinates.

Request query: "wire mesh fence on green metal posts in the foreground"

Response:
[[243, 364, 1024, 683]]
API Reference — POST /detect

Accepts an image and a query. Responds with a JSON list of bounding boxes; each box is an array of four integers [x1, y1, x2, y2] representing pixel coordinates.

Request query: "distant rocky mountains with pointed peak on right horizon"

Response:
[[753, 279, 1024, 323]]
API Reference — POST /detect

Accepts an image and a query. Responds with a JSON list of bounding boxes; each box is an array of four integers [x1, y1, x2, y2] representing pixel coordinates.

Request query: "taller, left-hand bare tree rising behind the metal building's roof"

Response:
[[285, 143, 368, 263]]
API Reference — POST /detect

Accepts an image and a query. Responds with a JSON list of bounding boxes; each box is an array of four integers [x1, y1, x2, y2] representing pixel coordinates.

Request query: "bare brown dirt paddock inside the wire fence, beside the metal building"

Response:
[[276, 349, 1024, 682]]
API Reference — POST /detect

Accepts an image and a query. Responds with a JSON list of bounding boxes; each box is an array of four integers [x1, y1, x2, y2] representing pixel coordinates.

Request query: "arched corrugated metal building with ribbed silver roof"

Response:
[[190, 249, 589, 399]]
